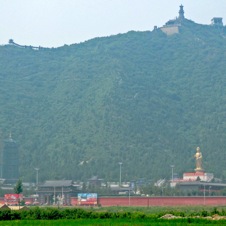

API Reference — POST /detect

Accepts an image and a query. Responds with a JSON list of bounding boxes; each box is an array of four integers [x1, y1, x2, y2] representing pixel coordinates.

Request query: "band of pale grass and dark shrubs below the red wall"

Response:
[[0, 206, 226, 221]]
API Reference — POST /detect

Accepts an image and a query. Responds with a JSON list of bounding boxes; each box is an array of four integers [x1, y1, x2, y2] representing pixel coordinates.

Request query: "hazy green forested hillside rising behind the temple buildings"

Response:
[[0, 20, 226, 181]]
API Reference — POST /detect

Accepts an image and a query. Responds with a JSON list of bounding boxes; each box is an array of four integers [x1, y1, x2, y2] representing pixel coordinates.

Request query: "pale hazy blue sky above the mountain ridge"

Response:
[[0, 0, 226, 47]]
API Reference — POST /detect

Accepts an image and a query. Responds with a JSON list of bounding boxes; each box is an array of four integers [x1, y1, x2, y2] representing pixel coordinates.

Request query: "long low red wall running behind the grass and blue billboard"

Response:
[[71, 196, 226, 207]]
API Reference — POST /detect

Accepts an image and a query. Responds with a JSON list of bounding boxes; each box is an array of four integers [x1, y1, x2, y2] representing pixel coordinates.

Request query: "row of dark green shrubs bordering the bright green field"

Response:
[[0, 207, 222, 220]]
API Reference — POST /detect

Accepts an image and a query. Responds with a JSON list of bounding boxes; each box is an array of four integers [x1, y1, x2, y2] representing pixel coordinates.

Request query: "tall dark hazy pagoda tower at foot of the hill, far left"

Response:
[[2, 134, 19, 183]]
